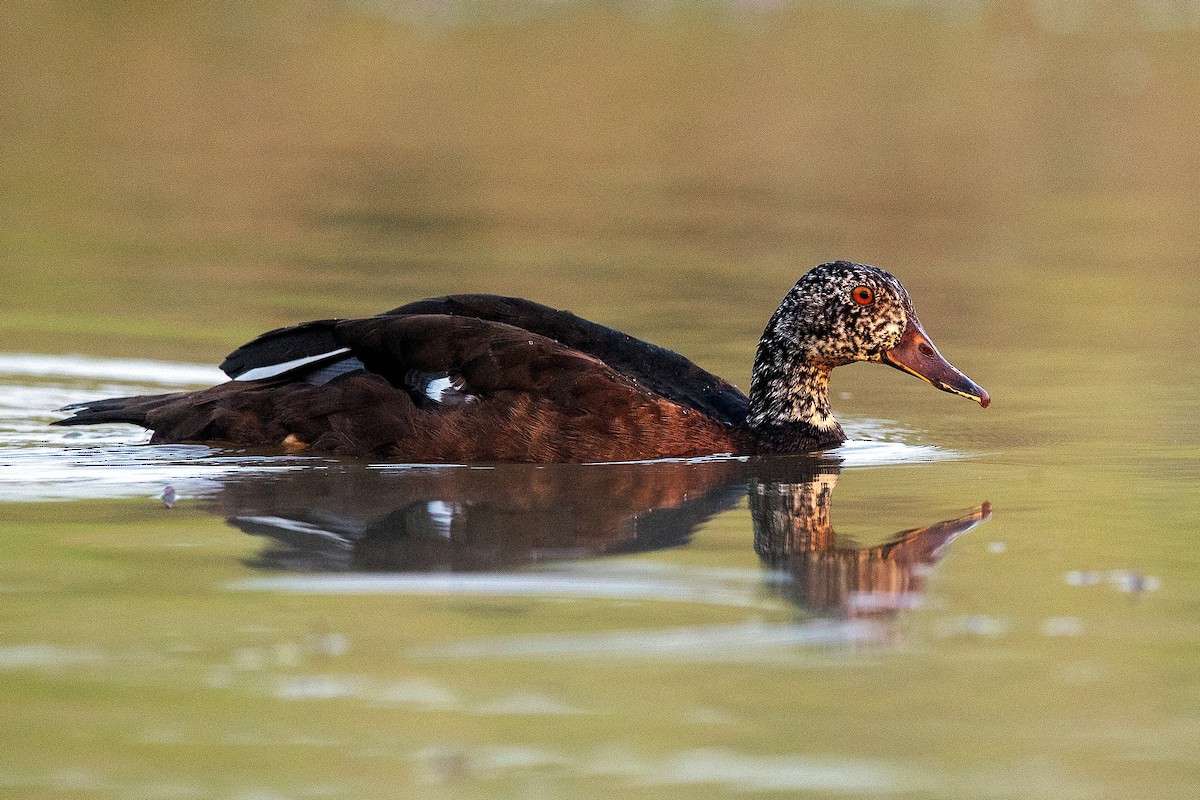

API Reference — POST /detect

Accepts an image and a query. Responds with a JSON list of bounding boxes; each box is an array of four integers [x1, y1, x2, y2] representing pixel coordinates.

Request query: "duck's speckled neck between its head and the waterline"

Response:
[[746, 338, 846, 453]]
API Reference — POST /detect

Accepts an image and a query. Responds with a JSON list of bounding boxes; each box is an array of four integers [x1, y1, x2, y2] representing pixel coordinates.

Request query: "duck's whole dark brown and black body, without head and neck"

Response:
[[66, 295, 750, 462]]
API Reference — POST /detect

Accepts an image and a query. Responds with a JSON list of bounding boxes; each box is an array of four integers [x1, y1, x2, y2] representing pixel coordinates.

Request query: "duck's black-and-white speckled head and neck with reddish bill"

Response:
[[748, 261, 990, 451]]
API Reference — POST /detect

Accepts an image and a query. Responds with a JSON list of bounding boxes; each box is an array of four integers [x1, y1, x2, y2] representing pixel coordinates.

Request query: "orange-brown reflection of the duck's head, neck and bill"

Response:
[[750, 470, 991, 616]]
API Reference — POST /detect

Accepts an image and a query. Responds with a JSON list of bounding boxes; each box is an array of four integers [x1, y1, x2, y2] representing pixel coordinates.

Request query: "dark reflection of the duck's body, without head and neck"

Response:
[[216, 461, 745, 572]]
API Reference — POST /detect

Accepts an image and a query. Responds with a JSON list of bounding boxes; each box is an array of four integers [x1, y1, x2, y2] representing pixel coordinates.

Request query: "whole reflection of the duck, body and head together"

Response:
[[214, 457, 989, 616]]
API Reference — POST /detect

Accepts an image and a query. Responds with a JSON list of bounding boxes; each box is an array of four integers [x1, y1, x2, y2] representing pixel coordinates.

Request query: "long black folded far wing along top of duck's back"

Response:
[[385, 294, 749, 426]]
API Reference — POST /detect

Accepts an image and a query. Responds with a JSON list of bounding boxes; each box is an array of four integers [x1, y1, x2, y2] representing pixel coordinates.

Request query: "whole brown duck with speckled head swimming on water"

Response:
[[54, 260, 991, 463]]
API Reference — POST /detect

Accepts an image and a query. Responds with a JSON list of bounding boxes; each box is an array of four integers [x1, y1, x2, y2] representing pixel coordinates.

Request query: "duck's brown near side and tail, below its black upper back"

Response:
[[60, 314, 749, 463]]
